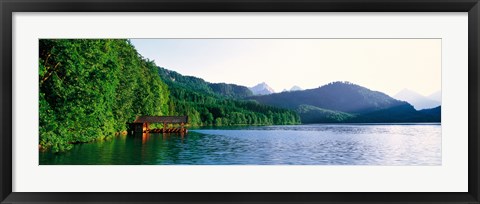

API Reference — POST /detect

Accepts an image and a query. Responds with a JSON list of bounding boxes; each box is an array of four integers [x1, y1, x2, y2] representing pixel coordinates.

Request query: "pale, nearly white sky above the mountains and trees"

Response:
[[131, 39, 441, 96]]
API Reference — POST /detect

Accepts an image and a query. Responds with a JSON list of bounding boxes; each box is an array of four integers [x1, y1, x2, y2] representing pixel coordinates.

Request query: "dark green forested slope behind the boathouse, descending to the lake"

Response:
[[159, 68, 300, 126]]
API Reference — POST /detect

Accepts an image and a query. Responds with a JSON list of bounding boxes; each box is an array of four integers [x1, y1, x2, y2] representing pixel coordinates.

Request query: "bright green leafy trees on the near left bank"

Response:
[[39, 40, 169, 152]]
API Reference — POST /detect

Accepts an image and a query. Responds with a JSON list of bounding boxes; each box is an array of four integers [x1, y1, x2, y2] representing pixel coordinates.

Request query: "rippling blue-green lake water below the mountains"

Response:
[[39, 124, 442, 166]]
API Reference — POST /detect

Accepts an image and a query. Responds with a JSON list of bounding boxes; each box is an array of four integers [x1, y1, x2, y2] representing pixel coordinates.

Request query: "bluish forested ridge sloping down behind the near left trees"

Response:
[[158, 67, 253, 98]]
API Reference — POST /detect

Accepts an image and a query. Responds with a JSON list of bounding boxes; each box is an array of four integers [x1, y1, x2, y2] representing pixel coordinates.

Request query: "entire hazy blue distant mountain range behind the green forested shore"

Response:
[[158, 68, 441, 123]]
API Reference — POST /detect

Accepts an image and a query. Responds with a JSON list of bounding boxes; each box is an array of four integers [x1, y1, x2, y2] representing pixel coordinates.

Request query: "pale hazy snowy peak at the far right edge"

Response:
[[393, 89, 440, 110]]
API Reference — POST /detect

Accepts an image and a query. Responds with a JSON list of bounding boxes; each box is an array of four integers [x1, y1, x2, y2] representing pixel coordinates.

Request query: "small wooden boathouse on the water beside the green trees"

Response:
[[128, 116, 188, 133]]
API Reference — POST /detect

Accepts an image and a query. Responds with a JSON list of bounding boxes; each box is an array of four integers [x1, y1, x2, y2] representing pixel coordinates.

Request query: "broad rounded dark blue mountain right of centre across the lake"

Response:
[[249, 82, 440, 123]]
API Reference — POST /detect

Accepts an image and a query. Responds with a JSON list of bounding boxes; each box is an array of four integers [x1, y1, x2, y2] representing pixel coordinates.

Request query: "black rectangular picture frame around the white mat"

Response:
[[0, 0, 480, 203]]
